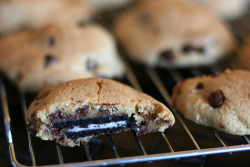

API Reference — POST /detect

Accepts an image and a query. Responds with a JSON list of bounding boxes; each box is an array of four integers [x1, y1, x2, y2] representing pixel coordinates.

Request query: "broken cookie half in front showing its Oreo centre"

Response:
[[27, 78, 175, 147]]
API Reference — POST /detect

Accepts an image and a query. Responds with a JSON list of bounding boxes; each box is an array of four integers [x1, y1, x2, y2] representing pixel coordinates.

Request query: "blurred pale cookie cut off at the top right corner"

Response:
[[188, 0, 249, 20]]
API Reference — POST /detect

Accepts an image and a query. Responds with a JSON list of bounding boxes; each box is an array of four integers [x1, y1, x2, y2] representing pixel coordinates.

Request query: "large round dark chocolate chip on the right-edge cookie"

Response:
[[208, 90, 225, 108]]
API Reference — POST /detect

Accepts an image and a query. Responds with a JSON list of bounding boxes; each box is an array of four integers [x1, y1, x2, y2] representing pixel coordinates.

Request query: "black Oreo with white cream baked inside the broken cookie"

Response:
[[52, 114, 136, 140]]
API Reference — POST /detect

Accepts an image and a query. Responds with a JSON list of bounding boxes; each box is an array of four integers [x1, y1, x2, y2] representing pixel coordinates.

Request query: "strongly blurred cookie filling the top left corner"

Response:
[[0, 0, 93, 35]]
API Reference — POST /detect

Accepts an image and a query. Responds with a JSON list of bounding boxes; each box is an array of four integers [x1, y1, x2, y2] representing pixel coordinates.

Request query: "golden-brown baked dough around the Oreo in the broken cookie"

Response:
[[27, 78, 175, 147]]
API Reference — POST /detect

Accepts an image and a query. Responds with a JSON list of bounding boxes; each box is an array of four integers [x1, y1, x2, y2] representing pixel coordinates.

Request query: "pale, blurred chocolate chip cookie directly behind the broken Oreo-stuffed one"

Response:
[[0, 24, 124, 92]]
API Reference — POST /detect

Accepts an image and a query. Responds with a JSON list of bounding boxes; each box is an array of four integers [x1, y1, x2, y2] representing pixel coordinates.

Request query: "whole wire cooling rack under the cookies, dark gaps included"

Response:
[[0, 5, 250, 167]]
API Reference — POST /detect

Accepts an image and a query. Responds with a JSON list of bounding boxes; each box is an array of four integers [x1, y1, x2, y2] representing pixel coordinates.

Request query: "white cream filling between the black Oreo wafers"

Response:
[[67, 121, 127, 132]]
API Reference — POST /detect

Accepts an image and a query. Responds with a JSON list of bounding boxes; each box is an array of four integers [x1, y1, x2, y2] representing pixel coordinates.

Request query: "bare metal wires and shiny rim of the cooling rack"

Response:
[[0, 6, 250, 167]]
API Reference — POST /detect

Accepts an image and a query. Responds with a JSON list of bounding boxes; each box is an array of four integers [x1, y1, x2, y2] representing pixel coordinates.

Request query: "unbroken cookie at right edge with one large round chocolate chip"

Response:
[[173, 70, 250, 135]]
